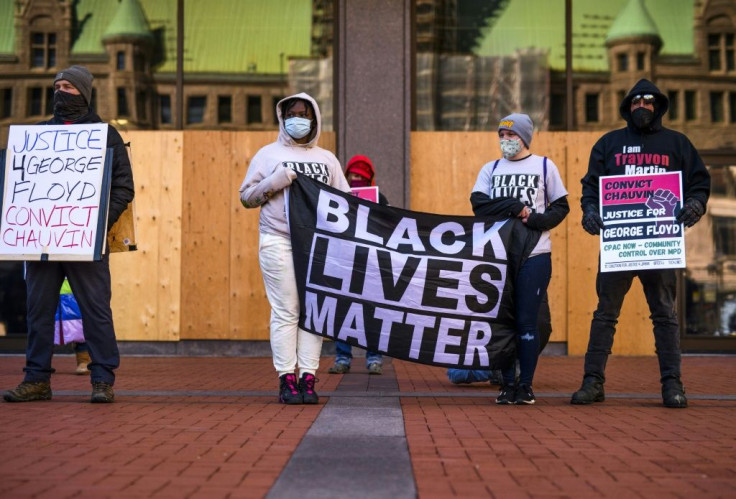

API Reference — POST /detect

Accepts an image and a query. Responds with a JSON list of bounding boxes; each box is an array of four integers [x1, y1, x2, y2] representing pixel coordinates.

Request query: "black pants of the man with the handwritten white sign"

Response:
[[23, 254, 120, 384]]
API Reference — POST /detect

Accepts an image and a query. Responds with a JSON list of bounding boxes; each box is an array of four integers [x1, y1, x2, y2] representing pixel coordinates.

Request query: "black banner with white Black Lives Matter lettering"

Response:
[[289, 175, 539, 369]]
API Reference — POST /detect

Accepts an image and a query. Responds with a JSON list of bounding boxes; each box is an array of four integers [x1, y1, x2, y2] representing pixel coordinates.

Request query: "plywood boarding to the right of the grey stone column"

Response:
[[411, 132, 653, 355]]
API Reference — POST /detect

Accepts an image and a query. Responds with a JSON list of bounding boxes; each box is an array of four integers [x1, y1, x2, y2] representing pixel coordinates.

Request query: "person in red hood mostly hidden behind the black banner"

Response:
[[327, 155, 388, 374]]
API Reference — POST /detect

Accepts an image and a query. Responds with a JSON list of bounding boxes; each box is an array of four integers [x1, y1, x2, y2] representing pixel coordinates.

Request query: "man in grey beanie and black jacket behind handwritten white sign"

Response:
[[3, 66, 134, 403]]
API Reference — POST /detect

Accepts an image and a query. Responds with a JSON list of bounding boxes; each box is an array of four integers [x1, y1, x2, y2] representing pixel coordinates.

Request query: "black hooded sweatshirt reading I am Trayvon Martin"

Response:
[[580, 79, 710, 212]]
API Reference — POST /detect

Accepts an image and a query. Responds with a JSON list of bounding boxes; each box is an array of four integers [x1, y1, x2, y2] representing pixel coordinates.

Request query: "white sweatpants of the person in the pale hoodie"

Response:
[[258, 233, 322, 376]]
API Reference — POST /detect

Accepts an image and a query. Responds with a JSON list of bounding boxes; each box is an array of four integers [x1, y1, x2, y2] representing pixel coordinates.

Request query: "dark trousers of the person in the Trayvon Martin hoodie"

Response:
[[585, 269, 680, 382]]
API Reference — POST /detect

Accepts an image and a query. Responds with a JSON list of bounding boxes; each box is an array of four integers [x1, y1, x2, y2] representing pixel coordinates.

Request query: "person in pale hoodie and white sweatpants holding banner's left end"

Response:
[[240, 93, 350, 404]]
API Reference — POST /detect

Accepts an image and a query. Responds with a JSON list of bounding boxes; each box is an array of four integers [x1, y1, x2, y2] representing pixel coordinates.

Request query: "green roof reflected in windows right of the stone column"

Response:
[[474, 0, 696, 72]]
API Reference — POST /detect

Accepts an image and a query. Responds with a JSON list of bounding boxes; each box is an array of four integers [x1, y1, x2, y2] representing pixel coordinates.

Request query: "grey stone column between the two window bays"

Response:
[[334, 0, 413, 207]]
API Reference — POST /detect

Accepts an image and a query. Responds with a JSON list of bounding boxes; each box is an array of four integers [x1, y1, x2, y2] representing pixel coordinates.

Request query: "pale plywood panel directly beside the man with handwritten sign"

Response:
[[110, 131, 182, 341]]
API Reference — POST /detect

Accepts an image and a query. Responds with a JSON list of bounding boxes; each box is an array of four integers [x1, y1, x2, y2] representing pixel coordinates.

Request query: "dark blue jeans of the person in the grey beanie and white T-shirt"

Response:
[[503, 253, 552, 386]]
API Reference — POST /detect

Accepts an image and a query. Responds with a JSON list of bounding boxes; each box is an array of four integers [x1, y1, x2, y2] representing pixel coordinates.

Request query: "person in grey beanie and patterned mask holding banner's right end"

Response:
[[470, 113, 570, 404]]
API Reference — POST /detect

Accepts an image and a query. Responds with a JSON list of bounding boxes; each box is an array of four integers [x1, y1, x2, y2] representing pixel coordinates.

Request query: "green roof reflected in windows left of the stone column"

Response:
[[75, 0, 312, 74]]
